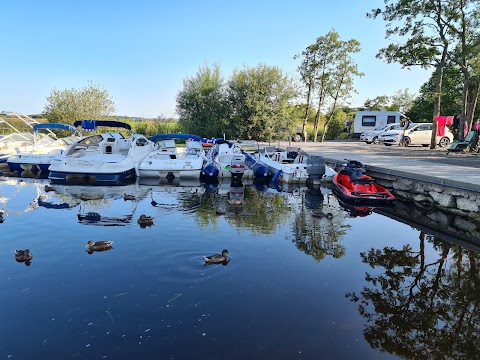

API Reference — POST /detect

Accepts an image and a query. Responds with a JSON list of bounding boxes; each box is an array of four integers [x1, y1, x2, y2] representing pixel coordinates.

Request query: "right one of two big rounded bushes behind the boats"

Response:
[[228, 64, 296, 140]]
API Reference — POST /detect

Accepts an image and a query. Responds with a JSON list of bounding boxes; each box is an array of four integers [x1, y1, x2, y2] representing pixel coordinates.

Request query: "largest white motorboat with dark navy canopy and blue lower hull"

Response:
[[48, 120, 153, 184]]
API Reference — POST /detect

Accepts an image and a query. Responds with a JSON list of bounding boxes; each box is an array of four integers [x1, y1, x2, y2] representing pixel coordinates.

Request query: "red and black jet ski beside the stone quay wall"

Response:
[[333, 160, 395, 204]]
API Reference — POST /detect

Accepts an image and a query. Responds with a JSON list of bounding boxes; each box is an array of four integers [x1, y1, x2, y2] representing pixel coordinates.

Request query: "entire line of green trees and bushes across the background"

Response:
[[40, 0, 480, 148]]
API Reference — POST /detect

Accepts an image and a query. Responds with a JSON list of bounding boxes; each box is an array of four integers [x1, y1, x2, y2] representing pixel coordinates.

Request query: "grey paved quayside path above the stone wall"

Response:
[[262, 141, 480, 191]]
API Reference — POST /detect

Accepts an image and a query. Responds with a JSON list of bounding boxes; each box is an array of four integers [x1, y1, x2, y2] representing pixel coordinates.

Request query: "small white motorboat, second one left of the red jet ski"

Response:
[[202, 139, 254, 180]]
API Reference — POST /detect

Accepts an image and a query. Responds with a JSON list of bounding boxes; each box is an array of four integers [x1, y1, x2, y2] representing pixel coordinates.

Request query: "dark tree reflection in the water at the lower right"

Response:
[[346, 232, 480, 359]]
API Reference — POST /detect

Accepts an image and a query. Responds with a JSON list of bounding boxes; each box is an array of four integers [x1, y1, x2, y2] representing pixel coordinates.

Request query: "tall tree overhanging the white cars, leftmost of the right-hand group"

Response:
[[367, 0, 455, 149]]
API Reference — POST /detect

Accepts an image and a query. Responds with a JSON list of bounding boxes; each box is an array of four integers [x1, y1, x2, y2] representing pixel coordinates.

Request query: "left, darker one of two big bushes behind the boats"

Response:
[[177, 64, 228, 137]]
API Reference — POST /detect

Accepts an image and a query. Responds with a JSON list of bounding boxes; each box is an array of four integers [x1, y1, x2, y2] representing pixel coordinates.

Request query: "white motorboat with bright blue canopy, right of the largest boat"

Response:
[[138, 134, 206, 180]]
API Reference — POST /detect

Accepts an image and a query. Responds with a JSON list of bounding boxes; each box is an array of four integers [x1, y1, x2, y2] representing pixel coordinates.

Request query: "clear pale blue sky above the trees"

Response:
[[0, 0, 431, 117]]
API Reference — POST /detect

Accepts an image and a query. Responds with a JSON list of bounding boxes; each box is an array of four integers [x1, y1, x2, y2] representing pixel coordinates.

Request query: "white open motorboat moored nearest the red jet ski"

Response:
[[255, 146, 336, 184]]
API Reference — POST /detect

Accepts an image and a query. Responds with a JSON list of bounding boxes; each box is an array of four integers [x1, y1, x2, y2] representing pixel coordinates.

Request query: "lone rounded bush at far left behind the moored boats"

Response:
[[43, 82, 115, 123]]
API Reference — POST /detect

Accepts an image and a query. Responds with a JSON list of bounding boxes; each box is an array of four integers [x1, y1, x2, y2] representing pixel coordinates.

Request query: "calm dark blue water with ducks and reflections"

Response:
[[0, 177, 480, 360]]
